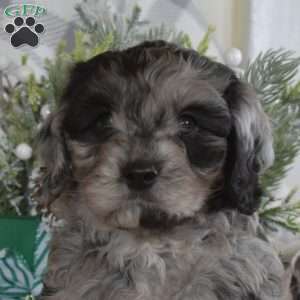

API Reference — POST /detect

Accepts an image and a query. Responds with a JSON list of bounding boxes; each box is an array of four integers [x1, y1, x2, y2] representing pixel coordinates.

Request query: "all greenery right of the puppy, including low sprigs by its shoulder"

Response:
[[244, 49, 300, 232]]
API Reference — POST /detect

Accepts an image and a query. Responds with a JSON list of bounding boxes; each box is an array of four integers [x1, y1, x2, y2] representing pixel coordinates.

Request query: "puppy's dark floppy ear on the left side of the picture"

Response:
[[38, 109, 71, 206]]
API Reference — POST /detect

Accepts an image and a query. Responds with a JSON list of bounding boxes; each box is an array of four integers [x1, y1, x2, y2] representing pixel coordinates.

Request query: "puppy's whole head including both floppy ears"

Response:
[[41, 41, 273, 228]]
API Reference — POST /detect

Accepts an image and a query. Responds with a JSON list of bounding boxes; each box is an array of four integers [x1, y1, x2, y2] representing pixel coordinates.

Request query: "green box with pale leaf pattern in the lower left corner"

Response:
[[0, 217, 50, 300]]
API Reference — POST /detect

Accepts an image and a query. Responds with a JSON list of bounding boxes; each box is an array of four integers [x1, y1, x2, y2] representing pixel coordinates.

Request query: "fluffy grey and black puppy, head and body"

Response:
[[40, 41, 288, 300]]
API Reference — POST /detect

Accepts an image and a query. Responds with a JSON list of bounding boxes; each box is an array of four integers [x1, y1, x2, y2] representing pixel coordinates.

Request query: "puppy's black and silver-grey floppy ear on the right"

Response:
[[224, 75, 274, 214]]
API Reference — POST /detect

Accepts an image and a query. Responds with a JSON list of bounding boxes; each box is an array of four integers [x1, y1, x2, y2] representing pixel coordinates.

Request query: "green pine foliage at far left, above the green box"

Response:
[[0, 57, 47, 215]]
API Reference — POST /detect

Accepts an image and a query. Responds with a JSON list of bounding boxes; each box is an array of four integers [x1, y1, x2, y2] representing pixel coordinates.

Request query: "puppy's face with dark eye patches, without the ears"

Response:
[[64, 60, 230, 226]]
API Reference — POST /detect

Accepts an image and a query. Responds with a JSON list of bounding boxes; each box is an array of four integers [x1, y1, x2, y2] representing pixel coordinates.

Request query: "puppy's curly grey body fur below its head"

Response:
[[43, 212, 289, 300]]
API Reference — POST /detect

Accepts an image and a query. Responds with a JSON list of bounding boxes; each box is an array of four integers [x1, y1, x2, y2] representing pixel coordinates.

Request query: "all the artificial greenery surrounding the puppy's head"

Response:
[[0, 0, 300, 231]]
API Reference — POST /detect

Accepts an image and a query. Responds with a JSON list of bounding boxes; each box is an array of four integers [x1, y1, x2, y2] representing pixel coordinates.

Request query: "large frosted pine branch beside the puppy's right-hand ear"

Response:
[[244, 49, 300, 191]]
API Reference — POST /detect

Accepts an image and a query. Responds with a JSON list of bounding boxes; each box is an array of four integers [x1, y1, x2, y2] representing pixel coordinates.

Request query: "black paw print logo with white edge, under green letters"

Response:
[[4, 17, 45, 47]]
